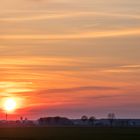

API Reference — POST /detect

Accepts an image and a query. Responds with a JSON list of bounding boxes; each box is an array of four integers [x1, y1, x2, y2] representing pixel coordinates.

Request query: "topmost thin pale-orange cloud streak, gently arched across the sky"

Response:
[[0, 11, 140, 22]]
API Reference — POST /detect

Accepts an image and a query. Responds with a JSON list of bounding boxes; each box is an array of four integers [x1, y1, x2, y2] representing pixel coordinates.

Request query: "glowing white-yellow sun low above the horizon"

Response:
[[4, 98, 17, 112]]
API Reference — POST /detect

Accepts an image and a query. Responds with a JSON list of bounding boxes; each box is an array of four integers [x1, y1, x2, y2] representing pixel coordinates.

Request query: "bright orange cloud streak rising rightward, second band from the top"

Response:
[[0, 28, 140, 40]]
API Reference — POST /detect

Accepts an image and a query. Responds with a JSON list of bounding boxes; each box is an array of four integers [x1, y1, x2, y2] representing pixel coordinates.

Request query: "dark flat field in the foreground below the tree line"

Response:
[[0, 127, 140, 140]]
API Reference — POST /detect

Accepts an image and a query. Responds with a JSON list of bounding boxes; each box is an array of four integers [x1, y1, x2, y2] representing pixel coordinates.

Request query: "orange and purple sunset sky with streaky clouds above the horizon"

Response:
[[0, 0, 140, 119]]
